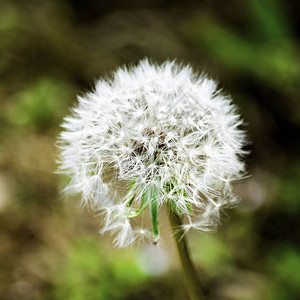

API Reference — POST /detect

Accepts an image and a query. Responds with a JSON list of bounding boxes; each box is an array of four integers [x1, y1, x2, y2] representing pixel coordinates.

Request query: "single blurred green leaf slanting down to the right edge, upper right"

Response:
[[184, 15, 300, 90]]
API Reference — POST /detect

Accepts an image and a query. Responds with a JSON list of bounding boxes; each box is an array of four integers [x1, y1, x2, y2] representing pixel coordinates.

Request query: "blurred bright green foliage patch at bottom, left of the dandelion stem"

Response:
[[54, 237, 147, 300]]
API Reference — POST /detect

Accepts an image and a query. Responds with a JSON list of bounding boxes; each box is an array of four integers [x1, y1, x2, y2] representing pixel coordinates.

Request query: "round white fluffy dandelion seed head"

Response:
[[58, 60, 246, 246]]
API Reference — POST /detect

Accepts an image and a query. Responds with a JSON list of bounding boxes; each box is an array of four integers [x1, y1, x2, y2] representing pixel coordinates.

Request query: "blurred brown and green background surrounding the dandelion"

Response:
[[0, 0, 300, 300]]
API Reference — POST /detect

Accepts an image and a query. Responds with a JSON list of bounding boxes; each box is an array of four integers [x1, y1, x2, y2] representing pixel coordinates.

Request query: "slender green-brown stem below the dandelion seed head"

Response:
[[168, 208, 205, 300]]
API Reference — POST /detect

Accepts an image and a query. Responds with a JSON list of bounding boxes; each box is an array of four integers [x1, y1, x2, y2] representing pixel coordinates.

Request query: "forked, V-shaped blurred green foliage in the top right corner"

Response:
[[185, 0, 300, 90]]
